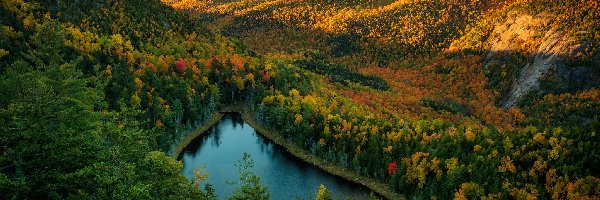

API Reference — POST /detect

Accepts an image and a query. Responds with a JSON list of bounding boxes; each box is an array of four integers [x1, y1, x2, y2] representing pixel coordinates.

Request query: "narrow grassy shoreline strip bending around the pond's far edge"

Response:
[[174, 106, 405, 199]]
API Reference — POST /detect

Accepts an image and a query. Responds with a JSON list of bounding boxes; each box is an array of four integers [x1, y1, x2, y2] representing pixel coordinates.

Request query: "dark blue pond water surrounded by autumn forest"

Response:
[[181, 114, 370, 199]]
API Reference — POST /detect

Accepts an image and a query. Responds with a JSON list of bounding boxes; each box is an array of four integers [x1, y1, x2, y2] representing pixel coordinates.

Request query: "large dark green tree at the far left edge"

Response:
[[0, 62, 102, 199]]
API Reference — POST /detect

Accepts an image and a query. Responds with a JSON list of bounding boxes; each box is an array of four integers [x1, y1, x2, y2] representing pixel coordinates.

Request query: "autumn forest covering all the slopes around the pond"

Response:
[[0, 0, 600, 199]]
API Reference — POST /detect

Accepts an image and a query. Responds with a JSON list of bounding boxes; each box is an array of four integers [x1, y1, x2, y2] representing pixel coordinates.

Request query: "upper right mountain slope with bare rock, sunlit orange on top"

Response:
[[450, 1, 600, 107]]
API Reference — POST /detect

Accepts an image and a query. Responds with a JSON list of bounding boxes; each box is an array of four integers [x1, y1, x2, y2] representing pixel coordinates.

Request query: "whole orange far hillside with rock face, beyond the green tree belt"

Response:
[[165, 0, 600, 126]]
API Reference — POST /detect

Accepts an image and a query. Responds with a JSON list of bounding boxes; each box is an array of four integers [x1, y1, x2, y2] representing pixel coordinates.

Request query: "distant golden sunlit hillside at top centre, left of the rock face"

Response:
[[166, 0, 507, 61]]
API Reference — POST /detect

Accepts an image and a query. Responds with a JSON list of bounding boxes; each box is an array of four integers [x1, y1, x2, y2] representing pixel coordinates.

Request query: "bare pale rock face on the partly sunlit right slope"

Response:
[[484, 14, 600, 108]]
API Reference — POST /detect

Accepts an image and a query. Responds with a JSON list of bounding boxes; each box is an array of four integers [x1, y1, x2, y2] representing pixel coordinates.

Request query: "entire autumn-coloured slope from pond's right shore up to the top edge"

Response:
[[167, 0, 600, 199]]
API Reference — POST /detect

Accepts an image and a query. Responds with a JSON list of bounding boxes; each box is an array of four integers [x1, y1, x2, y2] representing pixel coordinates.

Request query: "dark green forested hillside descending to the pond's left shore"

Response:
[[0, 0, 235, 199]]
